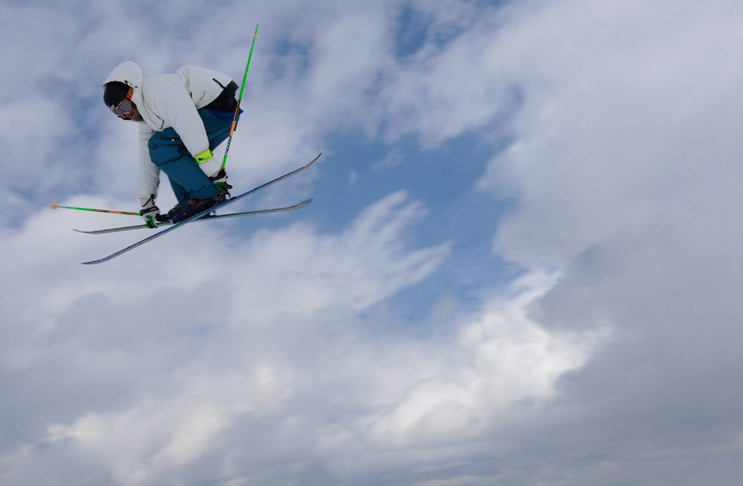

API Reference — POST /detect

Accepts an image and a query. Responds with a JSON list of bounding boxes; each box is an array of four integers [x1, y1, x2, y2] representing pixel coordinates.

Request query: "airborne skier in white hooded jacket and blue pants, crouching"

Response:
[[101, 61, 242, 228]]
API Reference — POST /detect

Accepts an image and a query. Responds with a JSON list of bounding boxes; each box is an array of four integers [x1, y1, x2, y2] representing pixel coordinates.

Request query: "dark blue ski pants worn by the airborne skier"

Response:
[[147, 108, 242, 208]]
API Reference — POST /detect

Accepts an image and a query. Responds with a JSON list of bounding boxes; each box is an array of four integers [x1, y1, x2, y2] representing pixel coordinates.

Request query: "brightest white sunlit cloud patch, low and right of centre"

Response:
[[364, 276, 601, 446]]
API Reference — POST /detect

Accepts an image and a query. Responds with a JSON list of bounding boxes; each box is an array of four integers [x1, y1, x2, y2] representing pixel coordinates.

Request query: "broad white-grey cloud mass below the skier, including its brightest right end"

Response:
[[2, 188, 603, 484]]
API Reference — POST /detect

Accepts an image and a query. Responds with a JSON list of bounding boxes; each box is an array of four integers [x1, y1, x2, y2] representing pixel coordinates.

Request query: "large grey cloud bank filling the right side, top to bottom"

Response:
[[464, 2, 743, 484]]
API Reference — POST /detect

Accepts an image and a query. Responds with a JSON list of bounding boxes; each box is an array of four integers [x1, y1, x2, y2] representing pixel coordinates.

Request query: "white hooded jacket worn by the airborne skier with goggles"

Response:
[[101, 61, 232, 199]]
